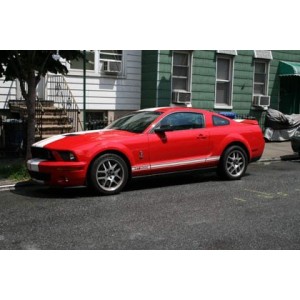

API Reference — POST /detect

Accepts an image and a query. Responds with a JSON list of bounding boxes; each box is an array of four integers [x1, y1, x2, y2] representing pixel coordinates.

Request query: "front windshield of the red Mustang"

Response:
[[106, 111, 161, 133]]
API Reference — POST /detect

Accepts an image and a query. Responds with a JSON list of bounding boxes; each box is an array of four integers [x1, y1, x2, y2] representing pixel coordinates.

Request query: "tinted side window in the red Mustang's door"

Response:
[[158, 112, 204, 131]]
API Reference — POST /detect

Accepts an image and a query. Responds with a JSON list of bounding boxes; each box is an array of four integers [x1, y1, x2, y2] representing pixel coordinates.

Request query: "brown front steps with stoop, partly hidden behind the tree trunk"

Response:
[[9, 100, 74, 140]]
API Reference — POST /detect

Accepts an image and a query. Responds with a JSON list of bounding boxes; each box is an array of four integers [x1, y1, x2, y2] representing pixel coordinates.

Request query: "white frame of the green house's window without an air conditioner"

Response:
[[214, 54, 234, 109]]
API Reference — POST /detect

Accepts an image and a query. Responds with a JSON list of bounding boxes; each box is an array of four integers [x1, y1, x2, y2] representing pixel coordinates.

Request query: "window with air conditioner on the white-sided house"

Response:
[[100, 50, 123, 75]]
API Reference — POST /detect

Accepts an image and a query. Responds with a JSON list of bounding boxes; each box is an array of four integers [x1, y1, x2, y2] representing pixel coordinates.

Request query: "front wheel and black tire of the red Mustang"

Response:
[[89, 153, 128, 195]]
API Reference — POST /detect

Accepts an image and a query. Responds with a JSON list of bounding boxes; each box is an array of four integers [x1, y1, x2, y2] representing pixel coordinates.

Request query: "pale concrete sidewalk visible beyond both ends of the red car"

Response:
[[0, 141, 298, 192]]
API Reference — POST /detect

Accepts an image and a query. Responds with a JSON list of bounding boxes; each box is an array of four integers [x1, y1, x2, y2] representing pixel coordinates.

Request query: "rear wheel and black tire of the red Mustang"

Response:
[[218, 145, 248, 180]]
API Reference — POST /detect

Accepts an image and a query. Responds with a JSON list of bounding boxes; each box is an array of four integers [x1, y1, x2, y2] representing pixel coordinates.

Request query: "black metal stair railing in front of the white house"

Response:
[[46, 75, 83, 131]]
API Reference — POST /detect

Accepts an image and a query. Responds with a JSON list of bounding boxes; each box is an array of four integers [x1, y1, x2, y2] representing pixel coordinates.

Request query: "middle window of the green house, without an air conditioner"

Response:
[[216, 56, 233, 107]]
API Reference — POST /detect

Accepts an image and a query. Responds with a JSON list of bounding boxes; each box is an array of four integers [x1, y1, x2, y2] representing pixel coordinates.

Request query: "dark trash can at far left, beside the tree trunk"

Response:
[[3, 119, 24, 151]]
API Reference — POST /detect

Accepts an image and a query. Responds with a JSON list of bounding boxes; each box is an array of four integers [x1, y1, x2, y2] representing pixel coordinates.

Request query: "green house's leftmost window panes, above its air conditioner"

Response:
[[172, 52, 191, 91]]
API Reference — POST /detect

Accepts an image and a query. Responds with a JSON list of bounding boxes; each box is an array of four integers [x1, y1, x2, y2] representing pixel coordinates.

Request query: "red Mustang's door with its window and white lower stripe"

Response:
[[149, 112, 211, 173]]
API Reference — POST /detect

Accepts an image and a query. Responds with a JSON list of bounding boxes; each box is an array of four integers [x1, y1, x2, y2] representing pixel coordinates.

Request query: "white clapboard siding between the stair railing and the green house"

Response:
[[66, 50, 142, 110]]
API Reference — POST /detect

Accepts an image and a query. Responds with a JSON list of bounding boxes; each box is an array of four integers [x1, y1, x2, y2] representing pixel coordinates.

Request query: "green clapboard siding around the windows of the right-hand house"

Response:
[[141, 50, 300, 116]]
